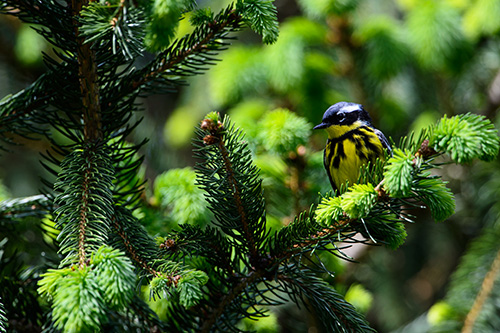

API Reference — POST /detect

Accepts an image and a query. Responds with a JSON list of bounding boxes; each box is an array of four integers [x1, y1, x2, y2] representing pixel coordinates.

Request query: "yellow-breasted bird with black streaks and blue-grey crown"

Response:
[[314, 102, 391, 190]]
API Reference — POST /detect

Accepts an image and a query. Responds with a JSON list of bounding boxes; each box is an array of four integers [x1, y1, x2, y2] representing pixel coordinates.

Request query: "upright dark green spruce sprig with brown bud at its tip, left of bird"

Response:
[[195, 113, 266, 265]]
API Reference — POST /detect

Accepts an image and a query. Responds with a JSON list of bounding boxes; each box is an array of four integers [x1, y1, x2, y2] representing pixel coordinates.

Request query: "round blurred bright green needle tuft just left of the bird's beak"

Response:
[[257, 109, 311, 154]]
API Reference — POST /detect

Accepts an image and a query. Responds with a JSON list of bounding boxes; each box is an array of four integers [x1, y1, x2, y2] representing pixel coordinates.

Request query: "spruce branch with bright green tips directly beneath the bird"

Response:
[[302, 114, 500, 253]]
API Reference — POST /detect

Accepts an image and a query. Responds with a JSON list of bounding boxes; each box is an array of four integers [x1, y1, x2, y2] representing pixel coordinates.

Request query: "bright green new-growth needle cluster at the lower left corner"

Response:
[[38, 246, 135, 332]]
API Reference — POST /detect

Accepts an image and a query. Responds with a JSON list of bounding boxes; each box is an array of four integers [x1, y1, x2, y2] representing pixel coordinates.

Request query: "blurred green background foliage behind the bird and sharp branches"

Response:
[[0, 0, 500, 332]]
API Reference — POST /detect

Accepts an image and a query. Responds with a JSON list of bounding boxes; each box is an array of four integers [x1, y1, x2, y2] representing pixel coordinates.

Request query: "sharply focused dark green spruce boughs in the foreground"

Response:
[[0, 0, 498, 332]]
